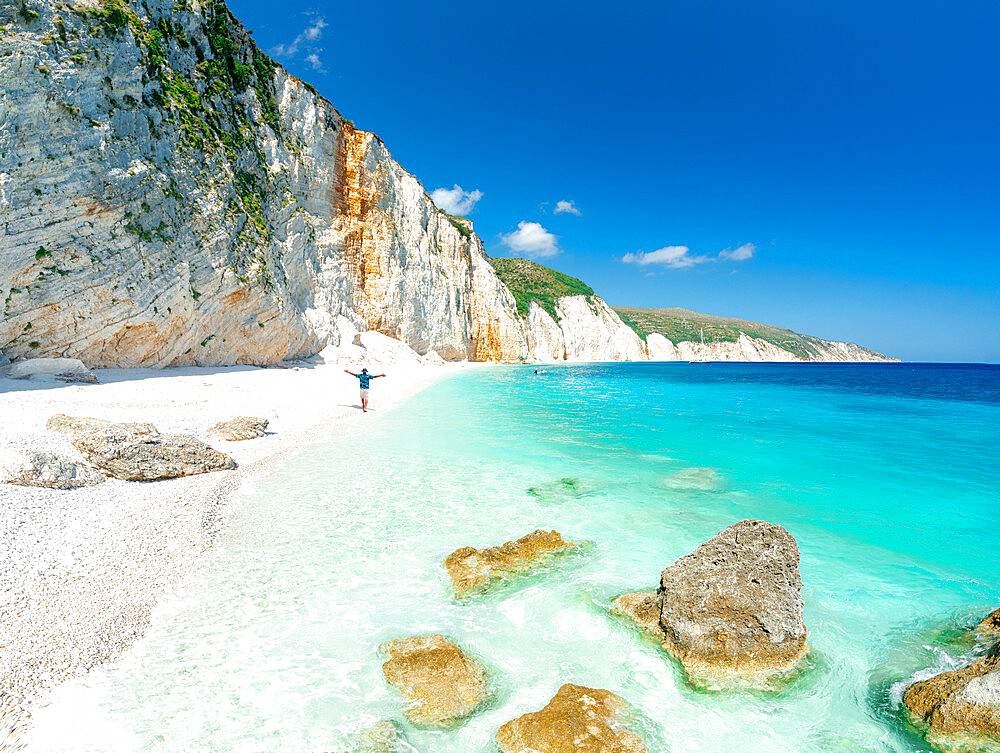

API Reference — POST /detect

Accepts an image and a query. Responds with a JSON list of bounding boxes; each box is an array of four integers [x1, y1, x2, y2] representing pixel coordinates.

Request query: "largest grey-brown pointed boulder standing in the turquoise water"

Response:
[[614, 520, 808, 687]]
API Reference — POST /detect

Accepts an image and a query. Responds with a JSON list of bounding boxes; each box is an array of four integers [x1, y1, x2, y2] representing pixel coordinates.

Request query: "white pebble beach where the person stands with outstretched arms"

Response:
[[0, 351, 470, 751]]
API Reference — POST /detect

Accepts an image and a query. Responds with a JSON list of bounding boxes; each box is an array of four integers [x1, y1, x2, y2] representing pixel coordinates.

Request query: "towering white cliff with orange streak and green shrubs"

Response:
[[0, 0, 527, 366]]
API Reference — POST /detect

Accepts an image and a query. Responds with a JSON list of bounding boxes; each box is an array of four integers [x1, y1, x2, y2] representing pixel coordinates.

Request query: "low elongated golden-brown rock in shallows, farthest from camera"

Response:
[[444, 530, 577, 595]]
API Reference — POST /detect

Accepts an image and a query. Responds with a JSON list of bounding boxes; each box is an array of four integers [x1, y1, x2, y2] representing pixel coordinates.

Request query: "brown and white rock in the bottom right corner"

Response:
[[903, 643, 1000, 749]]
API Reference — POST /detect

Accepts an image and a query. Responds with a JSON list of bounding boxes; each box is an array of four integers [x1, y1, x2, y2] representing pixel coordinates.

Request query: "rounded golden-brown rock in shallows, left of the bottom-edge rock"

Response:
[[379, 635, 489, 727]]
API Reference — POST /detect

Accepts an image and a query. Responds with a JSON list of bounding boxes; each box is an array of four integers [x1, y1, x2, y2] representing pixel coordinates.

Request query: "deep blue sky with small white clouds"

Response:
[[230, 0, 1000, 362]]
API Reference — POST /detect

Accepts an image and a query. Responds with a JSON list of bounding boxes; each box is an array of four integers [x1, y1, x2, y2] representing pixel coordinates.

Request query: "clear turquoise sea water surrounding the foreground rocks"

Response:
[[30, 364, 1000, 753]]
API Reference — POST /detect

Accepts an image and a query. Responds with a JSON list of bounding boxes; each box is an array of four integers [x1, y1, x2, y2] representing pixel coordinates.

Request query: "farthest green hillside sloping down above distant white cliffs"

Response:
[[611, 306, 852, 359]]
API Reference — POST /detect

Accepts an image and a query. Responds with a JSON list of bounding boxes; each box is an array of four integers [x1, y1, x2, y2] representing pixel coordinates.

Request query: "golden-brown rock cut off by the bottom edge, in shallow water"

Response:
[[496, 683, 646, 753]]
